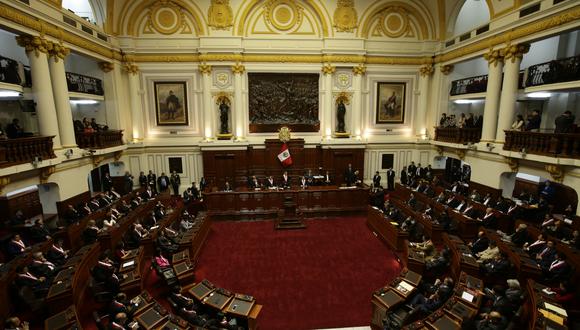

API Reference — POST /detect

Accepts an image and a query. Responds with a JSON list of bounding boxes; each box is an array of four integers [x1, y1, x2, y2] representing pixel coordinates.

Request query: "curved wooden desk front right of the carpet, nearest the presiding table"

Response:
[[367, 206, 409, 252]]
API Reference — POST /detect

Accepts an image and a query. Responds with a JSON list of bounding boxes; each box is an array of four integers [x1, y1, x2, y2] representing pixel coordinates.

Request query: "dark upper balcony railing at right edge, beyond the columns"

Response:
[[526, 55, 580, 87]]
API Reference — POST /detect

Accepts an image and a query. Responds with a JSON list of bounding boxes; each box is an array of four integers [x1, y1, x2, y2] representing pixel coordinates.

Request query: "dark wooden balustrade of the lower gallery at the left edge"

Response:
[[0, 136, 56, 167]]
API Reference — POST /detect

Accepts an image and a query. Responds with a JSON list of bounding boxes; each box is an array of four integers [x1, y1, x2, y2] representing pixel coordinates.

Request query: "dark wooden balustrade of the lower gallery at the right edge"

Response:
[[503, 131, 580, 158]]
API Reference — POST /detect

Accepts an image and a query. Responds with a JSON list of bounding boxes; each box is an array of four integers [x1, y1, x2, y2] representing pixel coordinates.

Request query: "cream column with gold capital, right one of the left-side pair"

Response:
[[48, 44, 77, 148]]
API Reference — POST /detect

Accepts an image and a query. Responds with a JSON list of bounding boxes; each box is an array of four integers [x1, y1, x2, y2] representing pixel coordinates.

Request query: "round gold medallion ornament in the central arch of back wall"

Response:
[[264, 0, 304, 31]]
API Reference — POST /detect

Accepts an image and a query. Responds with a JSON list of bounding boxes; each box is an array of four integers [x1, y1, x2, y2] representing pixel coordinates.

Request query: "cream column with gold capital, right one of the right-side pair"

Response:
[[495, 44, 530, 143]]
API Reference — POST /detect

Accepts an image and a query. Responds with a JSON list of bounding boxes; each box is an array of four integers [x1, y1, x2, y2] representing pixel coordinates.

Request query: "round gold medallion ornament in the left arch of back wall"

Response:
[[147, 0, 187, 35]]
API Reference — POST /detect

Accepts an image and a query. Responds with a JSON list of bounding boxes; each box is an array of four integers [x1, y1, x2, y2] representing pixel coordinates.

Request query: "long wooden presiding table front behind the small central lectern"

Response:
[[204, 186, 369, 220]]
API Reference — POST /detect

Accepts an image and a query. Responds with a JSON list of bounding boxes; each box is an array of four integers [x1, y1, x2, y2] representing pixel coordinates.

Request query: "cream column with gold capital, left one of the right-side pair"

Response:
[[481, 50, 503, 142]]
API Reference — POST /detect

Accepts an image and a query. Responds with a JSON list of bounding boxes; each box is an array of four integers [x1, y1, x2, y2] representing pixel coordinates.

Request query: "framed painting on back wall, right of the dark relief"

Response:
[[376, 82, 406, 124]]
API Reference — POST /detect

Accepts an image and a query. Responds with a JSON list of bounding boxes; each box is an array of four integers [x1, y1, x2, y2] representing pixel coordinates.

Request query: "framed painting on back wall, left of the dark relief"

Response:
[[153, 81, 189, 126]]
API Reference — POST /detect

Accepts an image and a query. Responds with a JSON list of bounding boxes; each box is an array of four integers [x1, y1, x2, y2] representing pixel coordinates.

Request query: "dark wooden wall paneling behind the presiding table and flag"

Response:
[[203, 139, 364, 189]]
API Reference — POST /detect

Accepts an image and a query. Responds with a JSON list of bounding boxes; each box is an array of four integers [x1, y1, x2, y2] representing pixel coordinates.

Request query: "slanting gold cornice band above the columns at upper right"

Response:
[[437, 6, 580, 62]]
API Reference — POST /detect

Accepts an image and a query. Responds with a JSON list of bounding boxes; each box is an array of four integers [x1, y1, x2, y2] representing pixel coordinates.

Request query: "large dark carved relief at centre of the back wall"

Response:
[[248, 72, 320, 133]]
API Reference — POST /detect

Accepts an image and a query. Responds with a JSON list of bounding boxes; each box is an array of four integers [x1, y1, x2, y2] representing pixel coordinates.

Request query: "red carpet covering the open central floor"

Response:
[[196, 217, 400, 330]]
